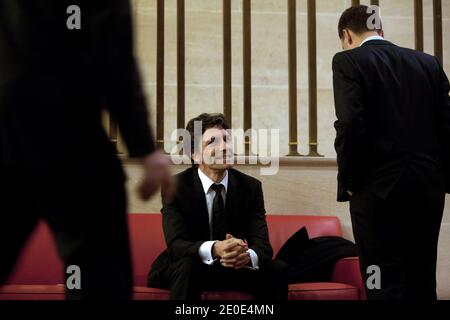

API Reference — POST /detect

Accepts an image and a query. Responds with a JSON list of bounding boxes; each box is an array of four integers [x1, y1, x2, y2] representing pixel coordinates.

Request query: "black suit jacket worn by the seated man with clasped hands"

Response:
[[150, 168, 273, 277]]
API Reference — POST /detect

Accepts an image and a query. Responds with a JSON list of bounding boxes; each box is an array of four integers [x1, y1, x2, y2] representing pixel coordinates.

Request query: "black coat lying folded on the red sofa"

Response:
[[276, 227, 358, 284]]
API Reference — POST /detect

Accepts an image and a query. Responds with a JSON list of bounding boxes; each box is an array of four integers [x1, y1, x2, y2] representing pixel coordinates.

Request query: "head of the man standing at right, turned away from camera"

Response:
[[338, 5, 384, 50]]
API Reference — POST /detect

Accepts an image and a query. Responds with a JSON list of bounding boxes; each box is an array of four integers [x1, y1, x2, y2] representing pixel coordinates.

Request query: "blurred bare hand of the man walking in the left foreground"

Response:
[[138, 151, 175, 200]]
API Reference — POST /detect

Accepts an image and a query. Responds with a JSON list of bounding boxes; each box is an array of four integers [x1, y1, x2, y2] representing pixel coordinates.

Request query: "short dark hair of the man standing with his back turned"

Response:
[[338, 5, 382, 39]]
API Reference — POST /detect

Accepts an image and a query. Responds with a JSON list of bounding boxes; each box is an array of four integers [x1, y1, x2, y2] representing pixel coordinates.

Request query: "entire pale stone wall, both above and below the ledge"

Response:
[[125, 0, 450, 299]]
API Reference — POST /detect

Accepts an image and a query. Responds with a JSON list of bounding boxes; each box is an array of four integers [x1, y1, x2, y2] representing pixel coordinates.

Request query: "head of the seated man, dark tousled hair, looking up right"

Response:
[[186, 113, 233, 173]]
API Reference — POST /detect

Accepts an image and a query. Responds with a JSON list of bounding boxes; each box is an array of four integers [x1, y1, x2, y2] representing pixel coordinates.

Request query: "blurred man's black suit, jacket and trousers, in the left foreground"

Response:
[[0, 0, 159, 298]]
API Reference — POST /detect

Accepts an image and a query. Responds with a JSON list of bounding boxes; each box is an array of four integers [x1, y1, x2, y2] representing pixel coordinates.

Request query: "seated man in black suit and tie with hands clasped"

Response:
[[148, 114, 287, 300]]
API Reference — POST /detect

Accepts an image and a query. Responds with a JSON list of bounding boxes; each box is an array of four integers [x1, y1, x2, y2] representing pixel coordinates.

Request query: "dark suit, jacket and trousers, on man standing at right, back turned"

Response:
[[333, 40, 450, 299]]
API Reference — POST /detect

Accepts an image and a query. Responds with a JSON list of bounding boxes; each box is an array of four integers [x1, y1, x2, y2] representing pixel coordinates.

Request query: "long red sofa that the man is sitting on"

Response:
[[0, 214, 365, 300]]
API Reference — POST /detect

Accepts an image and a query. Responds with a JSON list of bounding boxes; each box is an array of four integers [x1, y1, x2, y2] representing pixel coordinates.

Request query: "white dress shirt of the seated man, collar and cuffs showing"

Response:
[[197, 168, 259, 269]]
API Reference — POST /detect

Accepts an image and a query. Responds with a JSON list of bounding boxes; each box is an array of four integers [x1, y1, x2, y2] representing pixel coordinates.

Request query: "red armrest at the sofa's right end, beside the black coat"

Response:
[[331, 257, 366, 300]]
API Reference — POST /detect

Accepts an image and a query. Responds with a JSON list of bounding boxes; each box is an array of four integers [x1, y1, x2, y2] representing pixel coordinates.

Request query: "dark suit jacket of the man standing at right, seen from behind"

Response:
[[333, 40, 450, 201]]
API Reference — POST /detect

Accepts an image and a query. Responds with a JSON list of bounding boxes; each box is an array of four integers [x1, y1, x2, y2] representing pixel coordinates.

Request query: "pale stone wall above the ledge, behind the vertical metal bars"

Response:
[[128, 0, 450, 157]]
